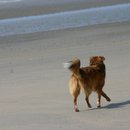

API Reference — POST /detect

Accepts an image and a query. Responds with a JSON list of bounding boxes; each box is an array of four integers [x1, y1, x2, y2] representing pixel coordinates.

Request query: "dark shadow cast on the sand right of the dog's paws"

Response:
[[101, 100, 130, 109]]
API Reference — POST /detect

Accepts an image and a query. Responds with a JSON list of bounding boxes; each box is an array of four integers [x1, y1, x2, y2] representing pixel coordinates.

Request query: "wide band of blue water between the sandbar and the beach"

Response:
[[0, 3, 130, 37]]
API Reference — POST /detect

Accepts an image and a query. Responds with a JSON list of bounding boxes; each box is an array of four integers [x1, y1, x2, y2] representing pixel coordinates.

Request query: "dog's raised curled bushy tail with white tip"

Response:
[[64, 58, 80, 72]]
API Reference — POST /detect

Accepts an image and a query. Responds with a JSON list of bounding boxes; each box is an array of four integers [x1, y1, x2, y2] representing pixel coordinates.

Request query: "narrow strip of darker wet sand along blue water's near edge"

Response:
[[0, 21, 130, 43]]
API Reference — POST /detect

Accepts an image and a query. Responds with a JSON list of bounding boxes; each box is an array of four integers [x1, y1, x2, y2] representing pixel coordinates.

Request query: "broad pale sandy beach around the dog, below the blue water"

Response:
[[0, 0, 130, 130]]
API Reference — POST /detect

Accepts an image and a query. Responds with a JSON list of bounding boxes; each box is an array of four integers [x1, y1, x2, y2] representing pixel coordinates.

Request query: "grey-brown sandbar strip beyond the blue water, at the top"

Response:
[[0, 0, 130, 19]]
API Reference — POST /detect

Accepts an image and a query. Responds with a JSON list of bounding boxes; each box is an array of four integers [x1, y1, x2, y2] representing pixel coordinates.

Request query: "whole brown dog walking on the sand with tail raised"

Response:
[[64, 56, 111, 112]]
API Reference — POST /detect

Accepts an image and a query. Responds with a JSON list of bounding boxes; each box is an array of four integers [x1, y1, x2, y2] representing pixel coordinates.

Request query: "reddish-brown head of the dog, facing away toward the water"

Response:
[[90, 56, 105, 65]]
